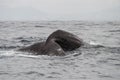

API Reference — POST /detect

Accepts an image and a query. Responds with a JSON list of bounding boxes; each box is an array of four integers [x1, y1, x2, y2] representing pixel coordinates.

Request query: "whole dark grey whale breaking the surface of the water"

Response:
[[18, 30, 83, 56]]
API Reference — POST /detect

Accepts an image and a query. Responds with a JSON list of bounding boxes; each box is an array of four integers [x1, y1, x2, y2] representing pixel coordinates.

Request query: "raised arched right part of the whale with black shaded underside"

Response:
[[46, 30, 83, 51]]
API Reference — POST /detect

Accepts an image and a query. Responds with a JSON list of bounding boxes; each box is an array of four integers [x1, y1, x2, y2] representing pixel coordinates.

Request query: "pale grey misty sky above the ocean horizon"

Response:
[[0, 0, 120, 21]]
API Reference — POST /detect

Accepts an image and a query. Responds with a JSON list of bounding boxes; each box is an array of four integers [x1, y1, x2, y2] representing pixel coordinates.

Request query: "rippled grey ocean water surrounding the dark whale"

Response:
[[0, 21, 120, 80]]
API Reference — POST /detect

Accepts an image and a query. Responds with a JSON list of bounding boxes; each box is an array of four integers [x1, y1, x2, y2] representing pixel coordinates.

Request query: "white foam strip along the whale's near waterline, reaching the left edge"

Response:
[[0, 50, 81, 59]]
